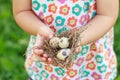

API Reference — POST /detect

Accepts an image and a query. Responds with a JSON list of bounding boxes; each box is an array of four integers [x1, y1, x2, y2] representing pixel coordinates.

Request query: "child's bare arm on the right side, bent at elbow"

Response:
[[81, 0, 119, 45]]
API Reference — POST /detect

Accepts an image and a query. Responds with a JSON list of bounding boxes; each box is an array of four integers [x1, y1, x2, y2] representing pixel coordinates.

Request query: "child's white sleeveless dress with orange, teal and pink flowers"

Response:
[[25, 0, 117, 80]]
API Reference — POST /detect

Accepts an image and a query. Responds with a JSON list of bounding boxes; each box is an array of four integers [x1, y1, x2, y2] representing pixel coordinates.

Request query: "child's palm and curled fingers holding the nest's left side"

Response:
[[33, 34, 53, 63]]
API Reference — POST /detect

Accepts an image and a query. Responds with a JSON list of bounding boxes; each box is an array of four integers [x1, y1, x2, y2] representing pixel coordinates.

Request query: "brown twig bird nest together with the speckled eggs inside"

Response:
[[43, 27, 86, 68]]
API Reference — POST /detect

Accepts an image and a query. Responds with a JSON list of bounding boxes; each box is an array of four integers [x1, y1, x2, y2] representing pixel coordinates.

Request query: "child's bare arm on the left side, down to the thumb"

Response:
[[13, 0, 52, 37]]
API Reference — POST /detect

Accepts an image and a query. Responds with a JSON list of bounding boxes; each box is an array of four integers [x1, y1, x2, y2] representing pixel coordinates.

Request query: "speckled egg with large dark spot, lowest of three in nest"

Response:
[[57, 49, 71, 61]]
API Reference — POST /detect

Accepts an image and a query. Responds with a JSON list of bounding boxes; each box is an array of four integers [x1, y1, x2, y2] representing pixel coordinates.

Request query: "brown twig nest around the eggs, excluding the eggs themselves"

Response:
[[43, 27, 87, 68]]
